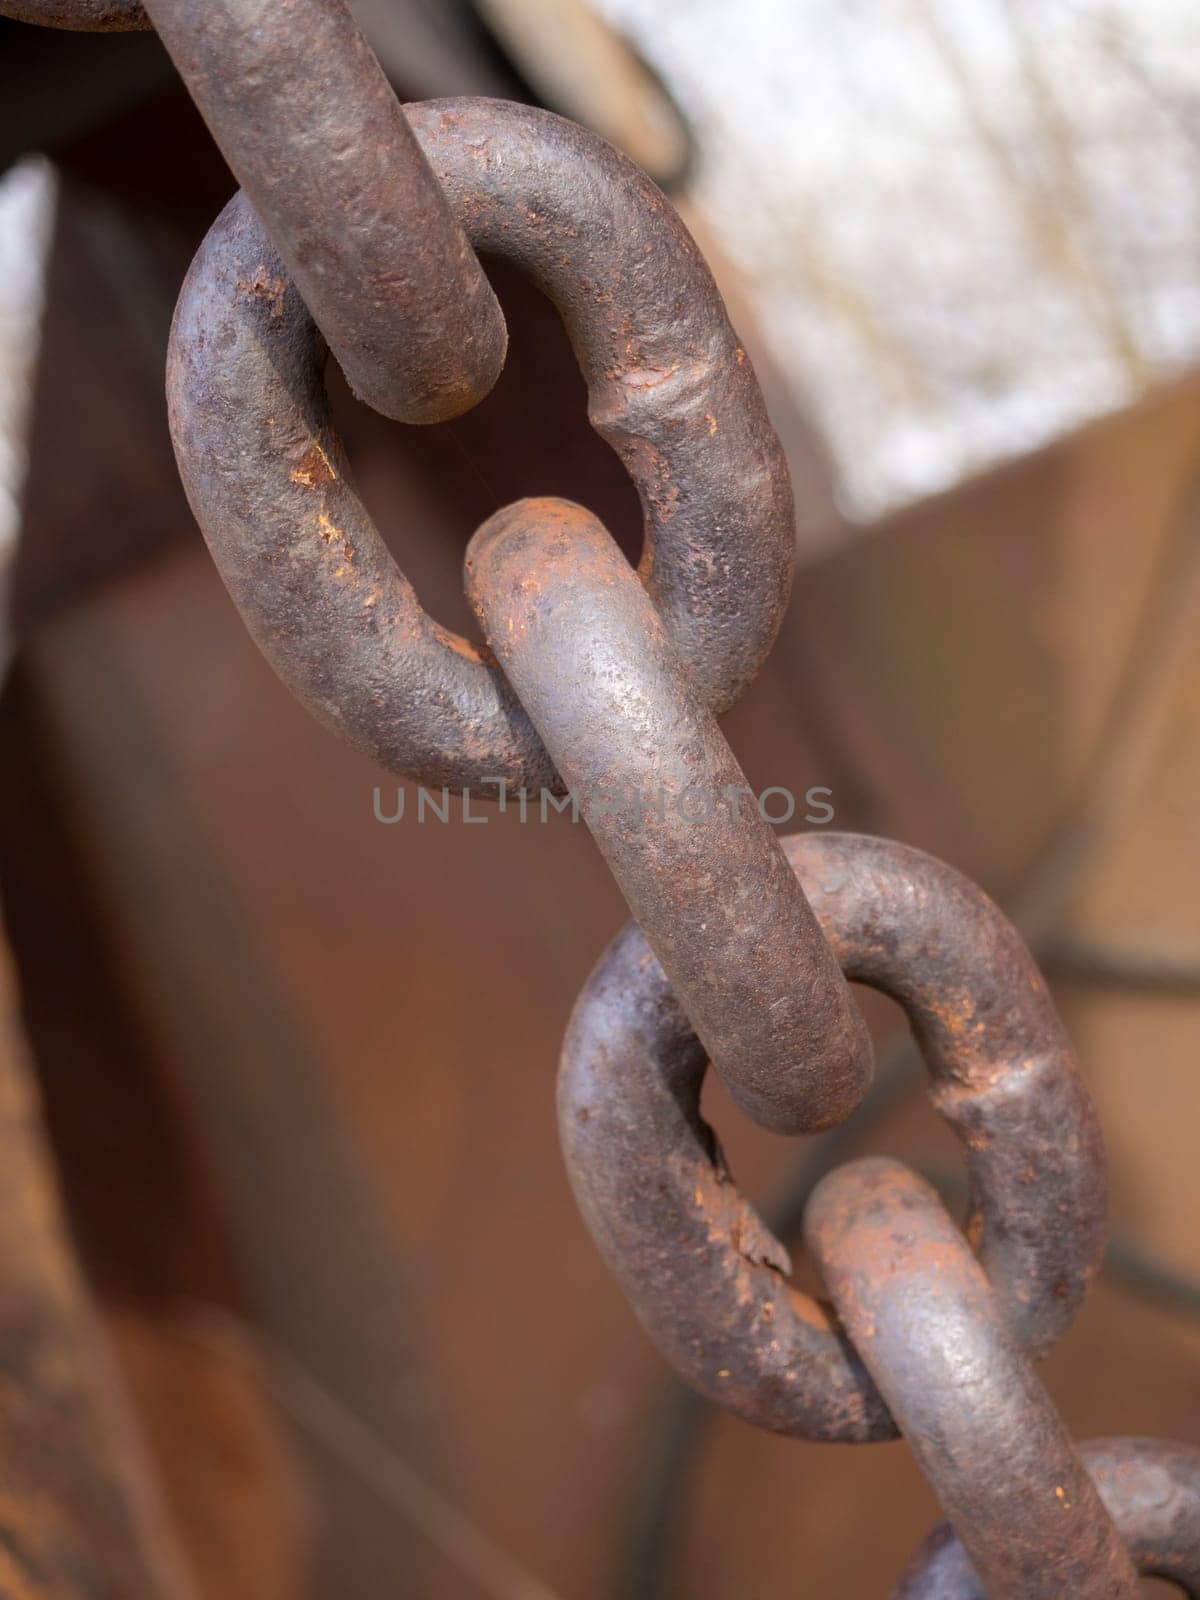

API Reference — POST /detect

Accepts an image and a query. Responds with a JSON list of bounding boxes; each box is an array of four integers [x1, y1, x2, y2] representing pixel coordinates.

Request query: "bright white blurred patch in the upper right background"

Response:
[[595, 0, 1200, 517]]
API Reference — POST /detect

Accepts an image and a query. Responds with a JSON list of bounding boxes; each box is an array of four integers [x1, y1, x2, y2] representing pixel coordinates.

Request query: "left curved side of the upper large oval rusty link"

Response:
[[166, 184, 558, 797]]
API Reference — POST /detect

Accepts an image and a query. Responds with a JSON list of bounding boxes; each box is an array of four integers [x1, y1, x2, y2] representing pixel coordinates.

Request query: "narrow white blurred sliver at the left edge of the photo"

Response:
[[0, 157, 58, 573]]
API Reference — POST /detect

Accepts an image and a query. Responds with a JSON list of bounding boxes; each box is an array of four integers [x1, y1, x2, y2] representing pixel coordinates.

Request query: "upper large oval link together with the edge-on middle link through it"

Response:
[[168, 90, 870, 1131]]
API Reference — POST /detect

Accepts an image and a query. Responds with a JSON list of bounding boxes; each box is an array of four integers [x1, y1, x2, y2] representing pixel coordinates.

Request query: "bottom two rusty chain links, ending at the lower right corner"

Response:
[[805, 1160, 1200, 1600]]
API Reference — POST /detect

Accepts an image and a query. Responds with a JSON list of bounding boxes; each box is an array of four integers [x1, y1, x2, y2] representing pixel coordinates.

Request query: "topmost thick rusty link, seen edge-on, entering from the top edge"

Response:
[[146, 0, 507, 422]]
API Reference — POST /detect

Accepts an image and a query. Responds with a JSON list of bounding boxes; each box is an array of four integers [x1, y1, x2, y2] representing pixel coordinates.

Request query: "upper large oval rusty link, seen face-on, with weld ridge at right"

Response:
[[168, 101, 794, 789]]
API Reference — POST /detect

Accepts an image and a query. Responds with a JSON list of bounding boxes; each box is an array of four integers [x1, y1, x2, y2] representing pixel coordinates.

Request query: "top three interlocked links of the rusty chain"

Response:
[[14, 0, 870, 1133]]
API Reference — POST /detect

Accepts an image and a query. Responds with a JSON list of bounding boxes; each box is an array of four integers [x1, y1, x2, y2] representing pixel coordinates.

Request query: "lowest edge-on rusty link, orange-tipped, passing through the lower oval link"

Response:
[[805, 1158, 1141, 1600]]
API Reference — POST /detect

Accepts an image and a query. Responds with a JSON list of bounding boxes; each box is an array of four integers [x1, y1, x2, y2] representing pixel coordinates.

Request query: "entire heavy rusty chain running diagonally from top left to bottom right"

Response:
[[0, 0, 1200, 1600]]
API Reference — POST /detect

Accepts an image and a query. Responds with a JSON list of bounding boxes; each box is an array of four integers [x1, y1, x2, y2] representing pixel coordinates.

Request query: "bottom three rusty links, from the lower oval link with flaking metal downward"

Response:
[[558, 834, 1200, 1600]]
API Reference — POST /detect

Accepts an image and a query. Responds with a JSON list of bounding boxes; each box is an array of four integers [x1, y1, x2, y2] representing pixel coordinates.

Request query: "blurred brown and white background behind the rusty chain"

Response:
[[0, 0, 1200, 1600]]
